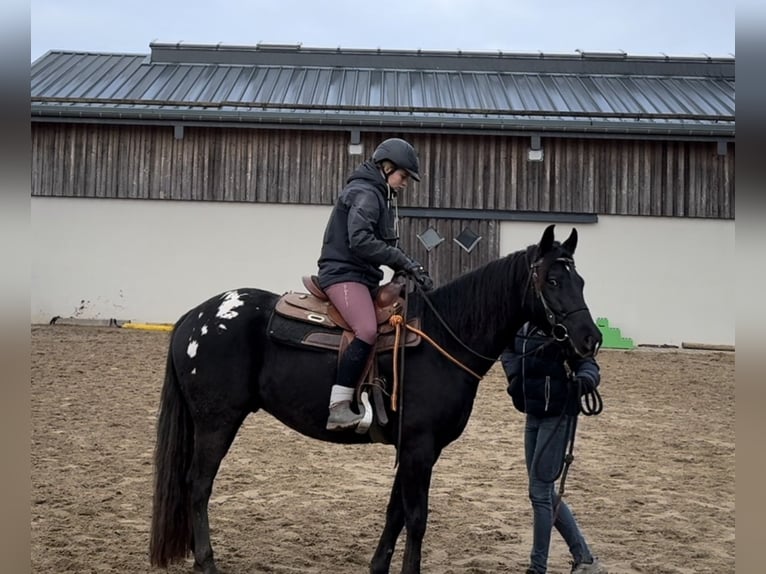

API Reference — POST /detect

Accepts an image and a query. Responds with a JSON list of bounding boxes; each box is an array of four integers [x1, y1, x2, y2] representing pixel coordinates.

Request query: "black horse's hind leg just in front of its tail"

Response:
[[188, 413, 247, 574]]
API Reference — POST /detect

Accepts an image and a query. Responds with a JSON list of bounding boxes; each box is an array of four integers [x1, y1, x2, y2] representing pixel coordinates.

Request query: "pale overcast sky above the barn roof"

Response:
[[30, 0, 735, 60]]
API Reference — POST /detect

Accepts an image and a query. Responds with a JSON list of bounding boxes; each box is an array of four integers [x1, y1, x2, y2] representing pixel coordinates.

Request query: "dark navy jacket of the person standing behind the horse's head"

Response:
[[500, 323, 601, 417]]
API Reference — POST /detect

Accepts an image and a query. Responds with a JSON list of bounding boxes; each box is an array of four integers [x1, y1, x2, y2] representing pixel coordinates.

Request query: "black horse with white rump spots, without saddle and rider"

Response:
[[149, 225, 601, 574]]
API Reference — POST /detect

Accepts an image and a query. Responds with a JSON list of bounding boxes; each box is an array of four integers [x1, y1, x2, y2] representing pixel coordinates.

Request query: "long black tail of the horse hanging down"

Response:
[[149, 315, 194, 568]]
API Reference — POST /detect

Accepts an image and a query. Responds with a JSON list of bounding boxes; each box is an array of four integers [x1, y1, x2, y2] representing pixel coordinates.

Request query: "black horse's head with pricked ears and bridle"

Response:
[[529, 225, 602, 356]]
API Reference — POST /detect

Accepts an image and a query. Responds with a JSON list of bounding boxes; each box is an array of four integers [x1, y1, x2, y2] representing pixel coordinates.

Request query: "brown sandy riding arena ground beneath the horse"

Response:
[[31, 325, 735, 574]]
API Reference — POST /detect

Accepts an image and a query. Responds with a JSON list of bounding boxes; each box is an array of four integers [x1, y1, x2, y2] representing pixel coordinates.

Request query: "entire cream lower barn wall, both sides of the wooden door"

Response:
[[31, 197, 736, 345]]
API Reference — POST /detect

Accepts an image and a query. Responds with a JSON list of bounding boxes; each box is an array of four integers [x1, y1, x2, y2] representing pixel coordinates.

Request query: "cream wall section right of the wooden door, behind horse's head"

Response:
[[500, 215, 736, 345]]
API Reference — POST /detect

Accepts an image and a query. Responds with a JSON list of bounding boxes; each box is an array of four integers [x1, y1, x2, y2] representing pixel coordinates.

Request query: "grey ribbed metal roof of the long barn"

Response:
[[31, 43, 735, 138]]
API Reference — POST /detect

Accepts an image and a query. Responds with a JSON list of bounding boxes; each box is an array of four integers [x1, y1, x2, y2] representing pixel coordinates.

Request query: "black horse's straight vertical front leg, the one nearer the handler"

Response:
[[397, 438, 439, 574]]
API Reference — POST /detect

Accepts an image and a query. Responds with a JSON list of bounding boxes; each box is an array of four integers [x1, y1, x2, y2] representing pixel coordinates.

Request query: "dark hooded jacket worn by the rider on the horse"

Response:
[[318, 161, 410, 289]]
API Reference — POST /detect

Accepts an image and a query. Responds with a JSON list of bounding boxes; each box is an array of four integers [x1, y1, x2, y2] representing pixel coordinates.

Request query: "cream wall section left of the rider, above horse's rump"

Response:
[[31, 197, 330, 323]]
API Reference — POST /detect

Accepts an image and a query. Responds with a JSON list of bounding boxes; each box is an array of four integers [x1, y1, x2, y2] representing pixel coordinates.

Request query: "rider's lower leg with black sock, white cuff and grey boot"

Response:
[[326, 339, 372, 430]]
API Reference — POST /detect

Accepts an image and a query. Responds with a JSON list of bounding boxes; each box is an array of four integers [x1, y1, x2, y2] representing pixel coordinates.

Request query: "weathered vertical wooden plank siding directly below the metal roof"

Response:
[[32, 122, 735, 219]]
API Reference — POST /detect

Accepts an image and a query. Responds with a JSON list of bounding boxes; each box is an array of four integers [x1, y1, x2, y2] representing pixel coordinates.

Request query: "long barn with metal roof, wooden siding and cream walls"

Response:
[[31, 42, 735, 345]]
